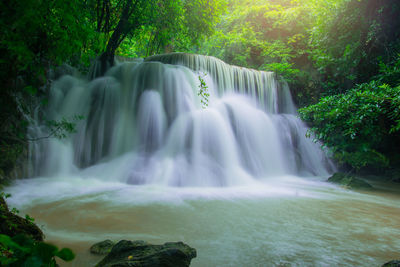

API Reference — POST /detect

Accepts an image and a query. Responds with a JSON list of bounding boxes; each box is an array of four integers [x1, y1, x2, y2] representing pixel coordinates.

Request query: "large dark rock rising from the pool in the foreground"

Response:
[[96, 240, 196, 267]]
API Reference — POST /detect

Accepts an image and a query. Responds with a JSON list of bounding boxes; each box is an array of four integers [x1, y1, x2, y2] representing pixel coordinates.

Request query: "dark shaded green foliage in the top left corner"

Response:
[[0, 0, 99, 77]]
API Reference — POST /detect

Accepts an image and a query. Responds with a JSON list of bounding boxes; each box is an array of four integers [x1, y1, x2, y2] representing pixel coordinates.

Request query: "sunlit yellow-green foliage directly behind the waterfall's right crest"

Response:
[[198, 0, 332, 106]]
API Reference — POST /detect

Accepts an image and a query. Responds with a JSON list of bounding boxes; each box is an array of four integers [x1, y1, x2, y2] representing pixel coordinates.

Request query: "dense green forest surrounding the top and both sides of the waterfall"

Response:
[[0, 0, 400, 180]]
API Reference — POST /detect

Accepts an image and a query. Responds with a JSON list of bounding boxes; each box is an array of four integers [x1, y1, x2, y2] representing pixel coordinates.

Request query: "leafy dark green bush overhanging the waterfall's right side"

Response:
[[299, 63, 400, 169]]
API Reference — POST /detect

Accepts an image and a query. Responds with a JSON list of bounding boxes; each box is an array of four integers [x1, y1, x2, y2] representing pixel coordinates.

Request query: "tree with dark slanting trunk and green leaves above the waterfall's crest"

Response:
[[93, 0, 224, 68]]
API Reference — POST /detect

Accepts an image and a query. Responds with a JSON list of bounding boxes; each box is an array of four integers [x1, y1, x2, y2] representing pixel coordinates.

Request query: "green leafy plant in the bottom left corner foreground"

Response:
[[0, 235, 75, 267]]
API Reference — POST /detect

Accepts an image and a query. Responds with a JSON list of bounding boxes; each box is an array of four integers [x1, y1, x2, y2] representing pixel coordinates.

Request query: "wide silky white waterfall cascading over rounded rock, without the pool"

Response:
[[29, 53, 334, 186]]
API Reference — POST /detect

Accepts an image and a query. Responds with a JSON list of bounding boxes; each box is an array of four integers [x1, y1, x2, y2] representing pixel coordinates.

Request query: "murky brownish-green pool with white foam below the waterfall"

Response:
[[3, 176, 400, 266]]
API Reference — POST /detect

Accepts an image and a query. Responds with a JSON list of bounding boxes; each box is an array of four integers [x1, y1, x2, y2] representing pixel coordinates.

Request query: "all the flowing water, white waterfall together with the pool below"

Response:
[[3, 54, 400, 266]]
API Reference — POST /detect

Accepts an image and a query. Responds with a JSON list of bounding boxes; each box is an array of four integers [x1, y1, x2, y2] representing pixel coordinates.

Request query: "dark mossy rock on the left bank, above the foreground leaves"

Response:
[[0, 197, 44, 241]]
